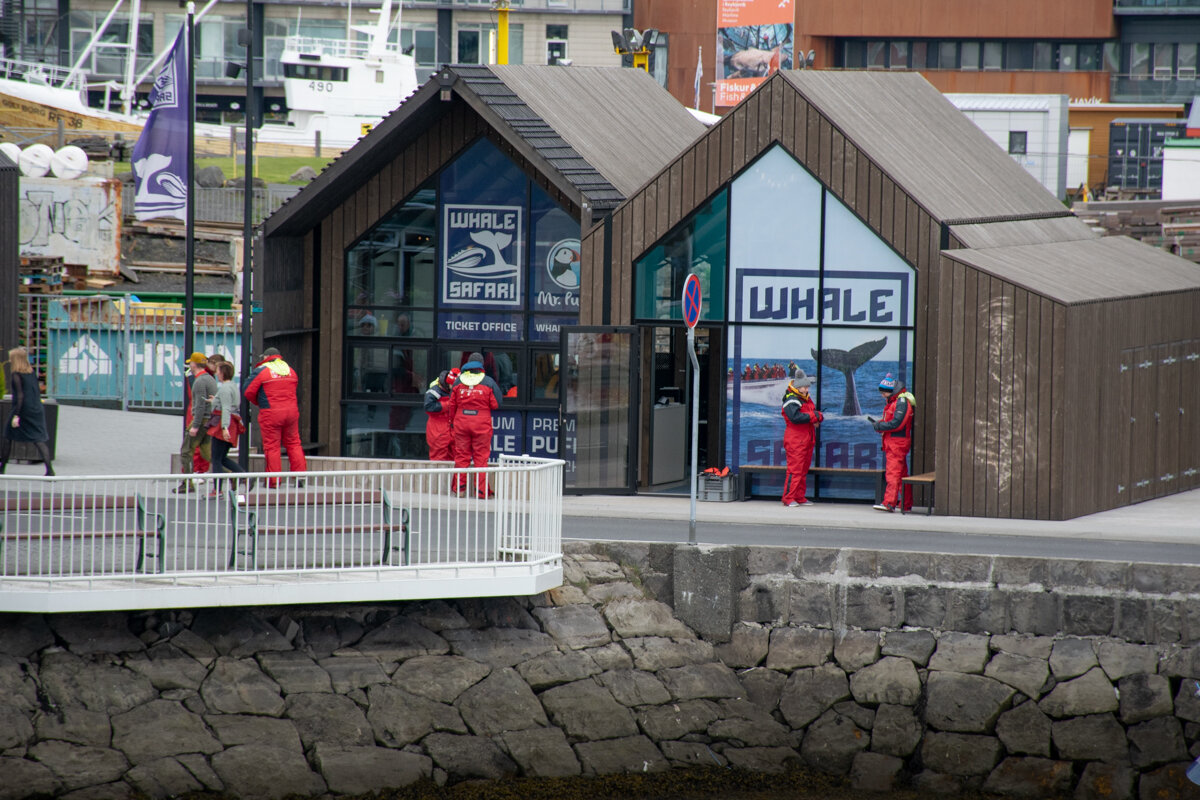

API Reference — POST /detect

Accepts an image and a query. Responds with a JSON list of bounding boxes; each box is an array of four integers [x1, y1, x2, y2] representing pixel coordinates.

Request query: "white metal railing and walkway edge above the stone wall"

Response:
[[0, 456, 563, 610]]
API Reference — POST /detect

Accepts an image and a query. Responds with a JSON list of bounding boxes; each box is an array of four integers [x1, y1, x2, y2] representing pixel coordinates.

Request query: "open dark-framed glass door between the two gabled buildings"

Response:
[[558, 325, 640, 494]]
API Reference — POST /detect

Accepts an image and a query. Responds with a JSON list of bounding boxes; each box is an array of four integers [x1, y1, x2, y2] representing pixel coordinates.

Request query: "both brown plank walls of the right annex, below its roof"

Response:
[[931, 258, 1200, 519]]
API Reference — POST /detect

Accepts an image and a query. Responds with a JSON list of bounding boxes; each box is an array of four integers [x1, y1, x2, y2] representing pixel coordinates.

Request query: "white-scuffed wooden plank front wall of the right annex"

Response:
[[929, 258, 1065, 519]]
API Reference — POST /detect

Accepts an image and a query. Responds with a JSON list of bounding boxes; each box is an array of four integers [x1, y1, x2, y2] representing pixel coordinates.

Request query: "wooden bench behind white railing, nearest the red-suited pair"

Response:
[[226, 487, 410, 570]]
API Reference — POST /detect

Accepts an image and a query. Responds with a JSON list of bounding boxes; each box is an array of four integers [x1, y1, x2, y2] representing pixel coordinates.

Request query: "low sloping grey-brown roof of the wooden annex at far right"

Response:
[[942, 236, 1200, 305]]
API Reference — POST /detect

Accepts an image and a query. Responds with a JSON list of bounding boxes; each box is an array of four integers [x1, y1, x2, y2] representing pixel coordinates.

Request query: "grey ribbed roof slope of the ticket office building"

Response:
[[488, 66, 708, 197]]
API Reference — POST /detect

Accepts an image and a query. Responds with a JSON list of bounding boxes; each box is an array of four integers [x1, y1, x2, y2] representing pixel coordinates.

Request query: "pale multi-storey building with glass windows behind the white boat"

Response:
[[0, 0, 631, 124]]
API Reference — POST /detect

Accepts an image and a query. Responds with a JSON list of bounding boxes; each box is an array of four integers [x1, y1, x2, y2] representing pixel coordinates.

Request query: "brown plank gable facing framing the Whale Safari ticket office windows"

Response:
[[292, 97, 580, 456]]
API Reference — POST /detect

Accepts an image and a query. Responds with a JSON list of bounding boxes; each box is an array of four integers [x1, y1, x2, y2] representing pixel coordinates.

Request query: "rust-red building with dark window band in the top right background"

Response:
[[634, 0, 1200, 112]]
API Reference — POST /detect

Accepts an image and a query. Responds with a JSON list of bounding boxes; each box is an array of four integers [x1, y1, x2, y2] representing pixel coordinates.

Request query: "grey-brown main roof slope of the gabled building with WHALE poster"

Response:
[[781, 70, 1062, 219]]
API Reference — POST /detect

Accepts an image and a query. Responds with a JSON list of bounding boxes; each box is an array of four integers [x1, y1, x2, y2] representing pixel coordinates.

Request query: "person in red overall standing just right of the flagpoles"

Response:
[[244, 348, 308, 488]]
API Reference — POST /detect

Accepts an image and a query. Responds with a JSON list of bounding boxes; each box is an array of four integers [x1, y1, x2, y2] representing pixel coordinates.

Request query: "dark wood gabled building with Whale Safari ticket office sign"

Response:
[[254, 66, 704, 474]]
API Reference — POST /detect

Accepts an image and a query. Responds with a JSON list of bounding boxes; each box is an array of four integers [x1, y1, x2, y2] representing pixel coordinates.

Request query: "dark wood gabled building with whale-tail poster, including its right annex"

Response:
[[581, 71, 1200, 519]]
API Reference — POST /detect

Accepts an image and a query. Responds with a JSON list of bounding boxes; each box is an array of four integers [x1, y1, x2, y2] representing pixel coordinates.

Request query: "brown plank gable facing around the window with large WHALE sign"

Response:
[[580, 76, 941, 489]]
